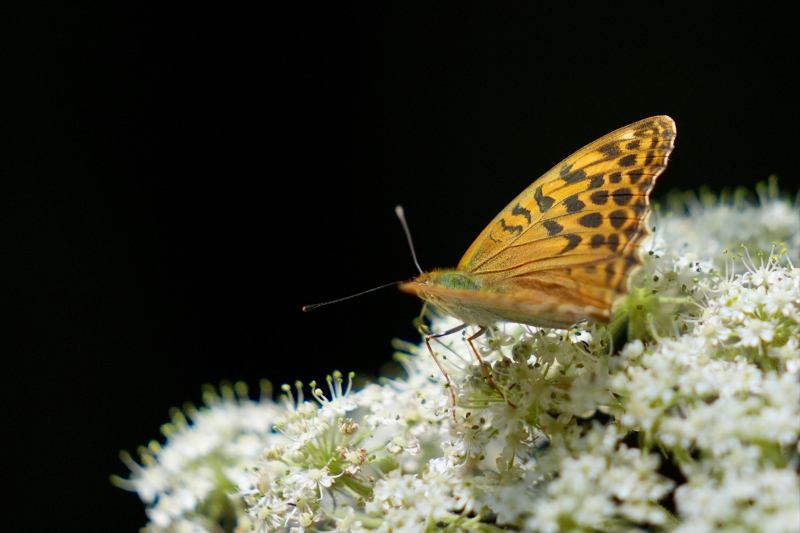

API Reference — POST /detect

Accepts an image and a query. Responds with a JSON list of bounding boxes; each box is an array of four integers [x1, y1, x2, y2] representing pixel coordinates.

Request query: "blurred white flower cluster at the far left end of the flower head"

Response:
[[112, 382, 283, 533]]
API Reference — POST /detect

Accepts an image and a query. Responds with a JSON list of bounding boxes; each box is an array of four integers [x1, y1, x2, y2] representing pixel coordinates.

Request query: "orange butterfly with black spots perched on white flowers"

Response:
[[399, 115, 675, 406]]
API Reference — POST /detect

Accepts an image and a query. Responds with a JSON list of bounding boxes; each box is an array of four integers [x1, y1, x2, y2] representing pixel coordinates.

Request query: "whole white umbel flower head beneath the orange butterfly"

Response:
[[114, 182, 800, 533]]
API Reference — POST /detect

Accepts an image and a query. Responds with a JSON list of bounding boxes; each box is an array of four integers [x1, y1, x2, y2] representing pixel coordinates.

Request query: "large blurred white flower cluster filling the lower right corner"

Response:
[[612, 257, 800, 533]]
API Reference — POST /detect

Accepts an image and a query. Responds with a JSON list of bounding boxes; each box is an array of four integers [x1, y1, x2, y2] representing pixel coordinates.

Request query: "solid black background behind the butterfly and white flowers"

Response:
[[6, 2, 800, 531]]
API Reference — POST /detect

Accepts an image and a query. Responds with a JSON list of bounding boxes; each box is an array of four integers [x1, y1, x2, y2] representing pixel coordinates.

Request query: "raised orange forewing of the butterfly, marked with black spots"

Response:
[[458, 116, 675, 283]]
